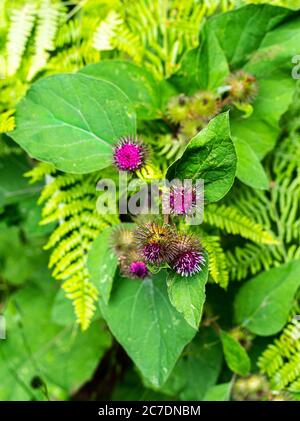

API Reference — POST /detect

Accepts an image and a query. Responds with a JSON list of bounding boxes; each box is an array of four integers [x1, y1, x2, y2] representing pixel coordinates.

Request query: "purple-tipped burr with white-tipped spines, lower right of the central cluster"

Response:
[[171, 235, 205, 276]]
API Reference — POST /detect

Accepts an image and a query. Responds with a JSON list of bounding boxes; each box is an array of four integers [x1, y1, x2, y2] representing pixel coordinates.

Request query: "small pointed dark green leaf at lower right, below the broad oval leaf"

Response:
[[220, 331, 251, 376]]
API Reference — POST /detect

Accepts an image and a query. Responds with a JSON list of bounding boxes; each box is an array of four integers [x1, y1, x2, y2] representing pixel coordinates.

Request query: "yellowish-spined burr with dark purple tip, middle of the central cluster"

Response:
[[135, 222, 176, 265]]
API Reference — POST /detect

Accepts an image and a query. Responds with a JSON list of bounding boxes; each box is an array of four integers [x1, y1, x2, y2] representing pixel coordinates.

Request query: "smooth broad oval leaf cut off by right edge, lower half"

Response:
[[234, 261, 300, 336]]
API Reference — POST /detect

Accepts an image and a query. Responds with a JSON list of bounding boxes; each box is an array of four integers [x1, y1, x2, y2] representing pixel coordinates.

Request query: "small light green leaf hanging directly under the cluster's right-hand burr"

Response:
[[167, 255, 208, 329]]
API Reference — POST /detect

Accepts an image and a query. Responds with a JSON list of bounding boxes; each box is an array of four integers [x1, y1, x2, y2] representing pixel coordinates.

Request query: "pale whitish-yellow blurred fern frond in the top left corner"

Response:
[[6, 3, 36, 76]]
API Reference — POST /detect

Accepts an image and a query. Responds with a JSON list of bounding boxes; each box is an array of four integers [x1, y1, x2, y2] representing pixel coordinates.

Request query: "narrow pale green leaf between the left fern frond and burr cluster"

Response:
[[87, 228, 118, 304]]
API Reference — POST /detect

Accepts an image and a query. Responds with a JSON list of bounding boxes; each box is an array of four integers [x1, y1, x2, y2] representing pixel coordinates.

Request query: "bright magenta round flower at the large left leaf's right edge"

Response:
[[113, 137, 147, 171]]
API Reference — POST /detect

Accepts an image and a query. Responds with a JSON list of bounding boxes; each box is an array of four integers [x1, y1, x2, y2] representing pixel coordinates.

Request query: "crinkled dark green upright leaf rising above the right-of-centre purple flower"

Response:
[[167, 113, 236, 202]]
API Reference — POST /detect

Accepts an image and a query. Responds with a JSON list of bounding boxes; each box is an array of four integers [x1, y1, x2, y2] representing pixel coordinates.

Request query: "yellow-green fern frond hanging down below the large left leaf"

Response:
[[33, 169, 117, 330]]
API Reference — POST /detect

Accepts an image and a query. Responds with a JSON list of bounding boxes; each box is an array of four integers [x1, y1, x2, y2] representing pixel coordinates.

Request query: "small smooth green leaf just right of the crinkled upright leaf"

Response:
[[233, 138, 269, 189]]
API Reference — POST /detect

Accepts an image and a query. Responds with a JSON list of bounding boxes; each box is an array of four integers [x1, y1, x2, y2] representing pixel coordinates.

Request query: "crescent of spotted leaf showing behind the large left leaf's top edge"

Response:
[[80, 60, 160, 119]]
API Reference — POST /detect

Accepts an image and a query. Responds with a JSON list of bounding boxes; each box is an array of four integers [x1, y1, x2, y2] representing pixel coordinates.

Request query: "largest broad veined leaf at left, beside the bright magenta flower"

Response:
[[10, 74, 136, 173]]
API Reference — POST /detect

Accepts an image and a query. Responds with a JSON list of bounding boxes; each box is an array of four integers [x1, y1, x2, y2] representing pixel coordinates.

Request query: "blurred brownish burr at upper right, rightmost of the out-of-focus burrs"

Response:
[[227, 70, 258, 103]]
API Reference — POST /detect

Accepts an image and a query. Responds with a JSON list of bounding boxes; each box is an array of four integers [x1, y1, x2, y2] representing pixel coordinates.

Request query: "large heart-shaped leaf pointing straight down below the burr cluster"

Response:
[[100, 271, 196, 386]]
